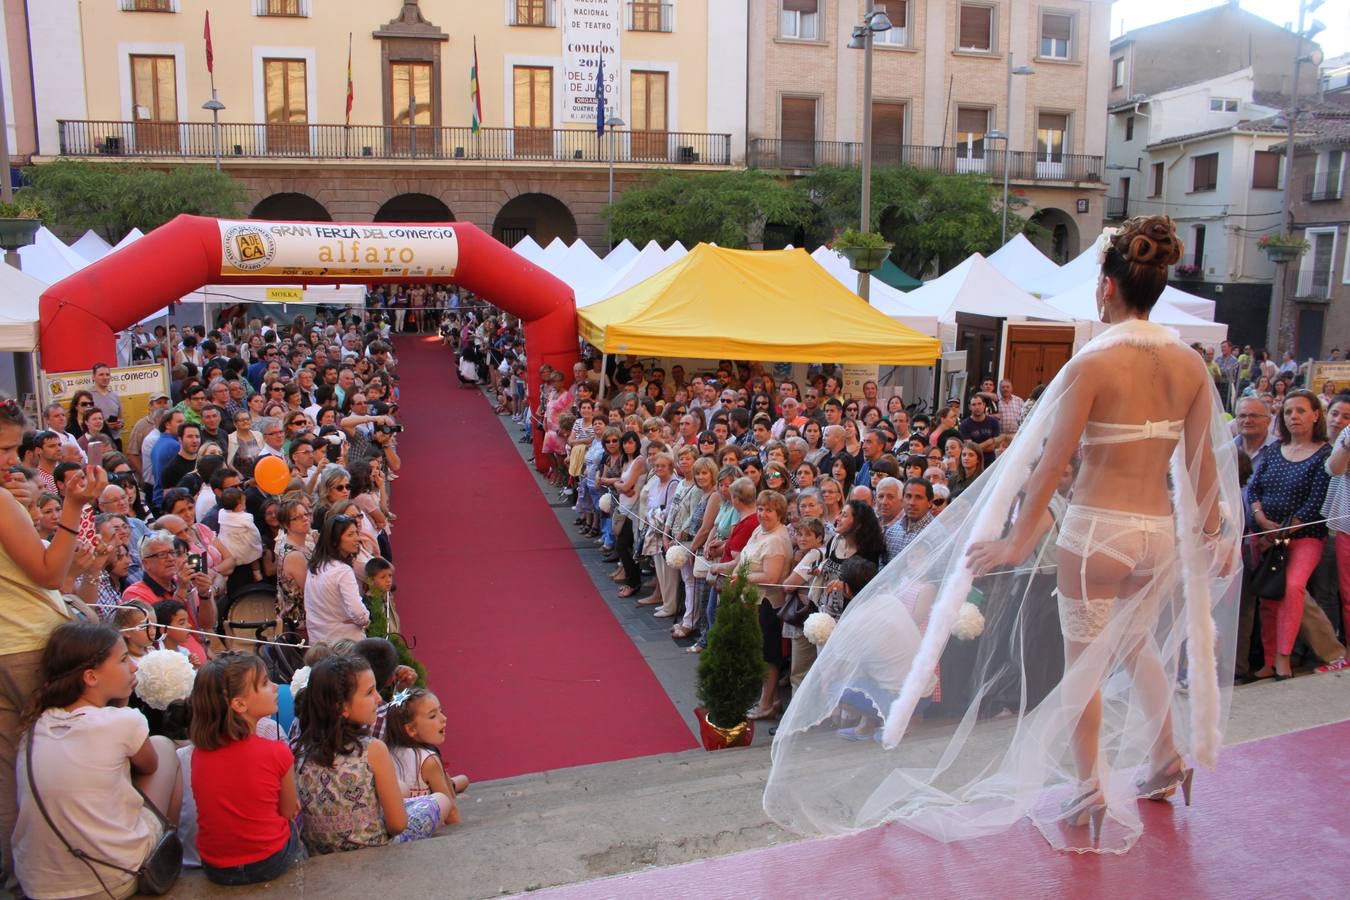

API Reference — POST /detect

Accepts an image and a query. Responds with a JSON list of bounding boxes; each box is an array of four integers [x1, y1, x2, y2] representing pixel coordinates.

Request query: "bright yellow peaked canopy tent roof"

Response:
[[576, 244, 941, 366]]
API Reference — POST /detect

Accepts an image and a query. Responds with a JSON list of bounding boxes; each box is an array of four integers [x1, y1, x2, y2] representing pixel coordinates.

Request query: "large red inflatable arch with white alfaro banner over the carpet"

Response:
[[39, 216, 576, 459]]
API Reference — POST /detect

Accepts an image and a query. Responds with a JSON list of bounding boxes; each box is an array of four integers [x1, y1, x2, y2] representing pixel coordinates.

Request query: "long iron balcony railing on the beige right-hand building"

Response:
[[745, 138, 1102, 181]]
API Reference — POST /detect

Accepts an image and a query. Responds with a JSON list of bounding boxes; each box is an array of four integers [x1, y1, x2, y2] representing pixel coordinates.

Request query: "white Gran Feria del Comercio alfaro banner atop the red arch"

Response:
[[220, 219, 459, 278]]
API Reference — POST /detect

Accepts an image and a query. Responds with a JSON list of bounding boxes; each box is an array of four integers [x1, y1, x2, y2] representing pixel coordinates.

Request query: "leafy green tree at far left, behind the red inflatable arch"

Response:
[[16, 159, 244, 243]]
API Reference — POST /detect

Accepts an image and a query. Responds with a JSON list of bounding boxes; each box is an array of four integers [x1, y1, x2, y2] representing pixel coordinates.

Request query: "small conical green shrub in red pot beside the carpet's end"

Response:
[[694, 565, 764, 750]]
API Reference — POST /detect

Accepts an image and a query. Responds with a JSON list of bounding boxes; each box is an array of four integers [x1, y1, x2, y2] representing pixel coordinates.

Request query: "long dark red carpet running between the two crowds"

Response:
[[393, 339, 695, 781]]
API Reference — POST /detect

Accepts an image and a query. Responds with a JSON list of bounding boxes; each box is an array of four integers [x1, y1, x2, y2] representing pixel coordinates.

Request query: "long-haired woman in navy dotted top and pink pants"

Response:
[[1247, 390, 1331, 681]]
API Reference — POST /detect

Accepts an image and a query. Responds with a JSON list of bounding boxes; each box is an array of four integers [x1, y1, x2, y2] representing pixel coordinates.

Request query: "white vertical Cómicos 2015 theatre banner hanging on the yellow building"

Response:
[[562, 0, 624, 124]]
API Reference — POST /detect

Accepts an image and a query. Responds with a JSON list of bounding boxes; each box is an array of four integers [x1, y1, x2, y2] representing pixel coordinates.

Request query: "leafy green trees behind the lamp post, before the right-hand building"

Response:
[[798, 166, 1034, 275]]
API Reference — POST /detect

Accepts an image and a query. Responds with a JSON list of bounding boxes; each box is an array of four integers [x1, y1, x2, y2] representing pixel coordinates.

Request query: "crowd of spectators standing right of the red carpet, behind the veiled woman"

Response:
[[456, 327, 1350, 737]]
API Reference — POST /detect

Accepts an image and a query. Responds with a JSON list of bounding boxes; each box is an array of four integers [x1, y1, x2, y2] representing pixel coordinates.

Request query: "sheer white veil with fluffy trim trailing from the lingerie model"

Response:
[[764, 320, 1242, 853]]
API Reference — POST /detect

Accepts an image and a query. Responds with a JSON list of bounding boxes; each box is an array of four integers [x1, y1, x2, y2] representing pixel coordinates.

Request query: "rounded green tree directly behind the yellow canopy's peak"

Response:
[[606, 170, 811, 247]]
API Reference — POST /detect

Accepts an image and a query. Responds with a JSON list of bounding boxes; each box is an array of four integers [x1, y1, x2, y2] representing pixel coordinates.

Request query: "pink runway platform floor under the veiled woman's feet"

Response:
[[543, 722, 1350, 900]]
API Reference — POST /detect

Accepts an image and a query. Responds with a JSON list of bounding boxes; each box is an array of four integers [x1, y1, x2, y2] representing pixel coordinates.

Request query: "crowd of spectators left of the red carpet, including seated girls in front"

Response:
[[0, 306, 467, 897]]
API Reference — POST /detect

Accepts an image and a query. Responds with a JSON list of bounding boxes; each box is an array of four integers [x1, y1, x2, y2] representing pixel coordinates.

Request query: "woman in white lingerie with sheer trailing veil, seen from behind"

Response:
[[765, 217, 1241, 853]]
